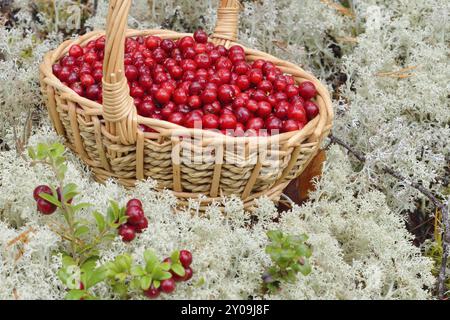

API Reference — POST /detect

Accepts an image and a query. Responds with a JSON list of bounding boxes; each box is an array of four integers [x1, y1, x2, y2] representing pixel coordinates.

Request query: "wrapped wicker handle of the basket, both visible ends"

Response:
[[103, 0, 240, 145]]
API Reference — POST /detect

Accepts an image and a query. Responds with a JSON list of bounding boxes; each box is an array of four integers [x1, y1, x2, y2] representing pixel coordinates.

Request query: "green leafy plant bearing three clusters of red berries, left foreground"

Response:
[[29, 143, 183, 300]]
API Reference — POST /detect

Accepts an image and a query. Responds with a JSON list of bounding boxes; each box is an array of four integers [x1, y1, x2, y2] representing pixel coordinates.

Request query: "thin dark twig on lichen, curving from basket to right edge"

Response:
[[329, 134, 450, 299]]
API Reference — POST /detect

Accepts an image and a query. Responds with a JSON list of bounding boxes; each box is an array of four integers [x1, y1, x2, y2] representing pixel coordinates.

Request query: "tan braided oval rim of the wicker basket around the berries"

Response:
[[39, 28, 334, 143]]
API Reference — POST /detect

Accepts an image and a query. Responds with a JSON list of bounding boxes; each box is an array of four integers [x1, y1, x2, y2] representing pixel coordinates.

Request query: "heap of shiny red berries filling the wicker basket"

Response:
[[53, 30, 319, 136]]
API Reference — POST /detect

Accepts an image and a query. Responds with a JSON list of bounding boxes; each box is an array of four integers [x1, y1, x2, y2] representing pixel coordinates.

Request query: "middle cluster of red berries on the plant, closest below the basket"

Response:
[[119, 199, 148, 242]]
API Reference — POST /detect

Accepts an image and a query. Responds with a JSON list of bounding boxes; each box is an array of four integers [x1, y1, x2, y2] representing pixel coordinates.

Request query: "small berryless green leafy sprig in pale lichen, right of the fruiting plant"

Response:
[[262, 230, 312, 293]]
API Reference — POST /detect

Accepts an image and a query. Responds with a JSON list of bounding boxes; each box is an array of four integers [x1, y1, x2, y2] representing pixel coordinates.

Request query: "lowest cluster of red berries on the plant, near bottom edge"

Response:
[[144, 250, 193, 299]]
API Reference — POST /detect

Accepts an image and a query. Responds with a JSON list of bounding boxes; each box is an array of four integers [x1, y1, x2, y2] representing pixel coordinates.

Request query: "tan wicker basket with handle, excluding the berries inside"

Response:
[[40, 0, 333, 208]]
